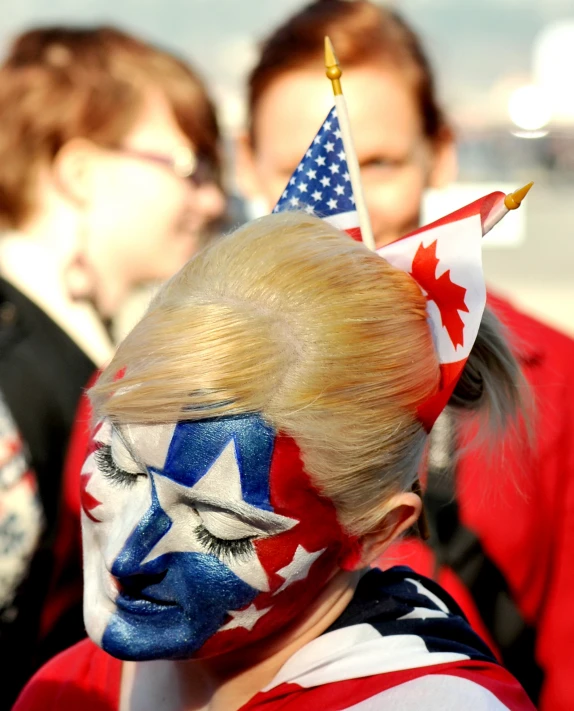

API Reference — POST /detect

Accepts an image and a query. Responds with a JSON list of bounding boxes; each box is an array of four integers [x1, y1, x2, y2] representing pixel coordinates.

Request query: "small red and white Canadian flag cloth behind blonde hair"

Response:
[[377, 192, 507, 430]]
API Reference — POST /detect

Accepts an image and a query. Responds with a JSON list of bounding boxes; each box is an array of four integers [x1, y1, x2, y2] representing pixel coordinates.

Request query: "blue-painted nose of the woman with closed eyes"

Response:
[[109, 479, 172, 579]]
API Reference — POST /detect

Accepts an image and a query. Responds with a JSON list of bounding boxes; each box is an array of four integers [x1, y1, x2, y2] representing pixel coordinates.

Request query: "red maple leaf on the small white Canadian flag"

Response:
[[411, 240, 468, 348]]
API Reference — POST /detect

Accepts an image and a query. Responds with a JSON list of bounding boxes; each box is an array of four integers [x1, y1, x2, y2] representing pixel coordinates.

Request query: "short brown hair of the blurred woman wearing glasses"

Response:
[[0, 27, 220, 227]]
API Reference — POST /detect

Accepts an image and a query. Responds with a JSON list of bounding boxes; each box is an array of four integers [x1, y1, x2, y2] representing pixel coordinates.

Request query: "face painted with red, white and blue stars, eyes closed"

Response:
[[82, 415, 351, 660]]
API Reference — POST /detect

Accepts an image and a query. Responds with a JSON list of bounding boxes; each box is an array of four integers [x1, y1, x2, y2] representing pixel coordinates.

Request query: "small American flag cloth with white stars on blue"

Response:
[[273, 107, 361, 241]]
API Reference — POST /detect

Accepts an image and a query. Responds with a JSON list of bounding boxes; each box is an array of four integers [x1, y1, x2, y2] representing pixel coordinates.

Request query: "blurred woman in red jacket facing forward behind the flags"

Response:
[[238, 0, 574, 711]]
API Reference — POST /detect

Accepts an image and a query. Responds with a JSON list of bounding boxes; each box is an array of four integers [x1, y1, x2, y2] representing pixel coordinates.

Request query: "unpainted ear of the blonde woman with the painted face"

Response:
[[346, 492, 422, 568]]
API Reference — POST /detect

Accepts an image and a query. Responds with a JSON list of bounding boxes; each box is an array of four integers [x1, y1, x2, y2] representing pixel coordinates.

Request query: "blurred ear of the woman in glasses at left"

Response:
[[52, 138, 101, 207]]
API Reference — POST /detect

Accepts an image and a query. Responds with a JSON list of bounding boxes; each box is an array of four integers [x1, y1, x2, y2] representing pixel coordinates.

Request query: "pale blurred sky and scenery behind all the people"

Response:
[[0, 0, 574, 333]]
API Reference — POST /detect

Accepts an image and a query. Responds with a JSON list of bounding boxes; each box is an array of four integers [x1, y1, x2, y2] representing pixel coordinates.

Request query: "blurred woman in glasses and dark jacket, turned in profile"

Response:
[[0, 27, 225, 708]]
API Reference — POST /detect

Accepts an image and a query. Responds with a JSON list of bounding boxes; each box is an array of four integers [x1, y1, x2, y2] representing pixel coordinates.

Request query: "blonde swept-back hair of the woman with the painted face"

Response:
[[91, 213, 524, 534]]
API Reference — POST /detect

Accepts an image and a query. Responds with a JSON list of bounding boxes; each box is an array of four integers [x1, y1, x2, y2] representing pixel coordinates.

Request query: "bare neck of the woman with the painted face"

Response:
[[124, 571, 361, 711]]
